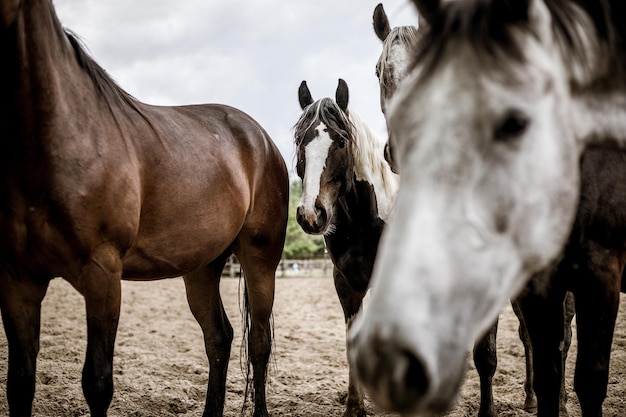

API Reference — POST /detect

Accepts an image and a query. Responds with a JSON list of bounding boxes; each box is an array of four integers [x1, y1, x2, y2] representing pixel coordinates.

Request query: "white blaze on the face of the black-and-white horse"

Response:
[[300, 123, 333, 214]]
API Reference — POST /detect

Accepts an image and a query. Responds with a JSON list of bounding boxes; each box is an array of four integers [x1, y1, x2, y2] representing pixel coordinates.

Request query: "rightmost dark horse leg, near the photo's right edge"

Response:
[[574, 252, 622, 417]]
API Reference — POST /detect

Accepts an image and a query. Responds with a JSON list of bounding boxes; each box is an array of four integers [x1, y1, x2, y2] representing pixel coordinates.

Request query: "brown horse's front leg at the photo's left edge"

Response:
[[0, 272, 49, 417]]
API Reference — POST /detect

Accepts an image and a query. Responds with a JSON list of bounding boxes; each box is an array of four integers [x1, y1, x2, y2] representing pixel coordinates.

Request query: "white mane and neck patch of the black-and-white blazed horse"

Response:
[[350, 112, 398, 221]]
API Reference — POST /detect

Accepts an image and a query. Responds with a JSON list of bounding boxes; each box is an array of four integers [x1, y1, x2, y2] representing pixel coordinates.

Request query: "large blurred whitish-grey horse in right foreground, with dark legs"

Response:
[[348, 0, 626, 416]]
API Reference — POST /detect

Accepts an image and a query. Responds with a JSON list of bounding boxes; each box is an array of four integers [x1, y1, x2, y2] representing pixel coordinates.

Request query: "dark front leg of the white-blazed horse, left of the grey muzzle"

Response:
[[333, 268, 367, 417]]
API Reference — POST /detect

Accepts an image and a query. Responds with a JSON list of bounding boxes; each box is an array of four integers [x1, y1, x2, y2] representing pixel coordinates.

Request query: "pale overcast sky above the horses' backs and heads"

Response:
[[54, 0, 417, 176]]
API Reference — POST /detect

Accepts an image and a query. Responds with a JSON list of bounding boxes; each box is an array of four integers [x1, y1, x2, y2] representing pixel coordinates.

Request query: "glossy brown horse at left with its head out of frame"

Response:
[[0, 0, 288, 417]]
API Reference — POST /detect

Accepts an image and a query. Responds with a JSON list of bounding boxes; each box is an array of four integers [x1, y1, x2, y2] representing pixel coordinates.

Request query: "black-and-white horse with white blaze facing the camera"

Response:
[[295, 80, 397, 417]]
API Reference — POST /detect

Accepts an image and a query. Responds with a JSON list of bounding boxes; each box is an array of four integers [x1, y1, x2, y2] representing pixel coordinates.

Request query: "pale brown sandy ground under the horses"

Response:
[[0, 278, 626, 417]]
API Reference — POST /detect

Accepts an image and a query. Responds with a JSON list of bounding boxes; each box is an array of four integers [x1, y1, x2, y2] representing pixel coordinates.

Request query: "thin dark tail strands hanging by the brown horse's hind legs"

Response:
[[239, 267, 274, 417]]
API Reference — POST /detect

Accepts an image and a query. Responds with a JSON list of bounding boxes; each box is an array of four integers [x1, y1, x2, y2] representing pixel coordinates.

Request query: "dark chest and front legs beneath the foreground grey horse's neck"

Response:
[[518, 149, 626, 417]]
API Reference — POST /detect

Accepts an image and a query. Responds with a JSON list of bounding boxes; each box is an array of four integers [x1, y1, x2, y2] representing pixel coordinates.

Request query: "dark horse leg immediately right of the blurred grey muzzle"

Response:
[[474, 319, 498, 417]]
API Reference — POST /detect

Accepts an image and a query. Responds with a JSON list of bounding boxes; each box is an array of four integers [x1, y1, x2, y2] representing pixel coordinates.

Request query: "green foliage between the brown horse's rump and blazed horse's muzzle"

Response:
[[283, 179, 324, 259]]
